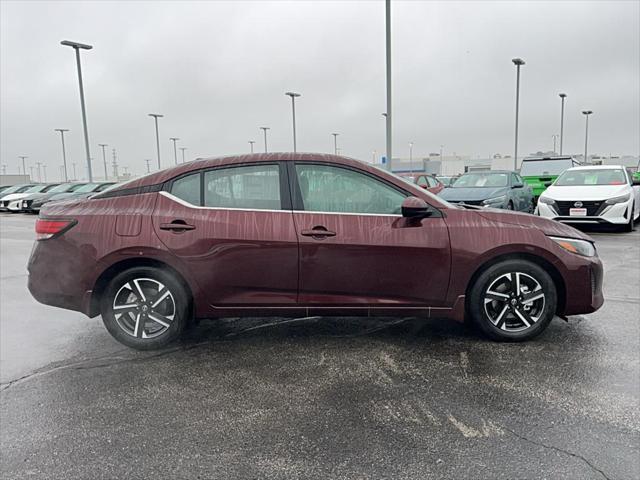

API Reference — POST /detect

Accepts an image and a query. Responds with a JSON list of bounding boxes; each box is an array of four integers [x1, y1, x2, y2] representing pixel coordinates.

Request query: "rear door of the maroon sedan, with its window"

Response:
[[153, 166, 298, 308]]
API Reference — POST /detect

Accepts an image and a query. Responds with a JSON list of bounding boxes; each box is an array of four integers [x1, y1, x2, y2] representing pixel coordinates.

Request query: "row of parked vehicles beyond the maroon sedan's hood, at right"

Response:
[[404, 156, 640, 231]]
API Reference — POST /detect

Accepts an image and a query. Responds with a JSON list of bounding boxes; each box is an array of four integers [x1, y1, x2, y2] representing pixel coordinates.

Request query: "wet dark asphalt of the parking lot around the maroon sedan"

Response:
[[0, 214, 640, 479]]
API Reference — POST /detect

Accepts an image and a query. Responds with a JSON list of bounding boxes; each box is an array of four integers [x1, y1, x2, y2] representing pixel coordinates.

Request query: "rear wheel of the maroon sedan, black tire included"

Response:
[[100, 267, 191, 350]]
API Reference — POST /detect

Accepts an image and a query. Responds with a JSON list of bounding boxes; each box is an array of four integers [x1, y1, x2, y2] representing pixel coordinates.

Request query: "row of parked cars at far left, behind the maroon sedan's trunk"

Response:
[[0, 182, 114, 213]]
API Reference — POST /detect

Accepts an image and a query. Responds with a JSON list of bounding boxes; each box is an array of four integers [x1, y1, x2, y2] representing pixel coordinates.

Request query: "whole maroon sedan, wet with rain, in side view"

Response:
[[28, 153, 603, 349]]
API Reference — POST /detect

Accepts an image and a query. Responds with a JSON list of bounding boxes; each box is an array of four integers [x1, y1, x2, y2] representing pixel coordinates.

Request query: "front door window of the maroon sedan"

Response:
[[296, 164, 406, 214]]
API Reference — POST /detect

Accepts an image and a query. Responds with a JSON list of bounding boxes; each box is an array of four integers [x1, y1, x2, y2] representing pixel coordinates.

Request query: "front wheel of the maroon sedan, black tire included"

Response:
[[467, 260, 558, 342]]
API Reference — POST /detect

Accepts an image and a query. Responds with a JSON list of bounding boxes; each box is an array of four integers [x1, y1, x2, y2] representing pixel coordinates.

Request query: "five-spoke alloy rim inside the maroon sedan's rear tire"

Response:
[[112, 278, 176, 339]]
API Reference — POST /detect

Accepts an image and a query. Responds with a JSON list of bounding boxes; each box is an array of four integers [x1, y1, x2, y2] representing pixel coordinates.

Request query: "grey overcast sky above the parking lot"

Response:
[[0, 0, 640, 179]]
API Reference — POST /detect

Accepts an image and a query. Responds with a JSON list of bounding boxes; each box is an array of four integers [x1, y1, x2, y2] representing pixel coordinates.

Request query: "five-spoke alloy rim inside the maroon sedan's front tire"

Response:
[[484, 272, 545, 332]]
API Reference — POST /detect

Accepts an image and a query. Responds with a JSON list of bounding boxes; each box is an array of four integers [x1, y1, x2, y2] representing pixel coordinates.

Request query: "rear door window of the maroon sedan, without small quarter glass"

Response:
[[204, 165, 281, 210]]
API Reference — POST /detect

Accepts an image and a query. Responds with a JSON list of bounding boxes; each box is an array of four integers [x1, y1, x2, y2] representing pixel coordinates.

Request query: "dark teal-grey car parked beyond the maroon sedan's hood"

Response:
[[440, 170, 535, 213]]
